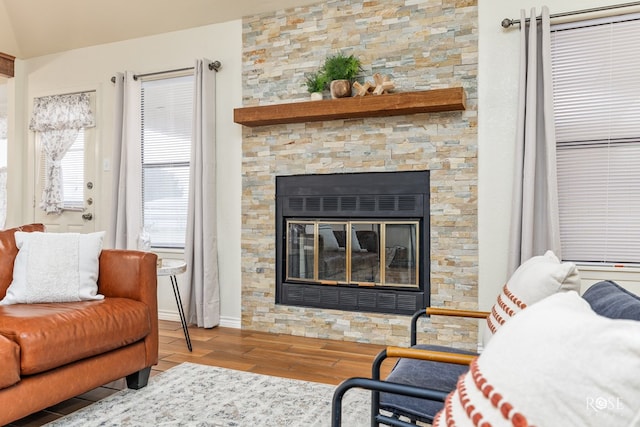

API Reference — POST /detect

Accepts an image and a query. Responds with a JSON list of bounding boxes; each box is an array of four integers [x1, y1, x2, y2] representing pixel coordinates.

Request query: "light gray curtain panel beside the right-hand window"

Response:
[[507, 6, 562, 276]]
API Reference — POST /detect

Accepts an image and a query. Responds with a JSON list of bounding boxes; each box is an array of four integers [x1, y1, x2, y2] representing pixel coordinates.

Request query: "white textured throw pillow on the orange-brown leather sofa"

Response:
[[0, 231, 104, 305]]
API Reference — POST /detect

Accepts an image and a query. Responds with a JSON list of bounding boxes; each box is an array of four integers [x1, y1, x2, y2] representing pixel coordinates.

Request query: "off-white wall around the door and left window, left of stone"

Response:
[[7, 20, 242, 326]]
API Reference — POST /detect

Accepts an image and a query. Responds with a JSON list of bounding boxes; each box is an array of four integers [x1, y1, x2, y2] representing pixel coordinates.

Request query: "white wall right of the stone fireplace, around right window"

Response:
[[478, 0, 637, 309]]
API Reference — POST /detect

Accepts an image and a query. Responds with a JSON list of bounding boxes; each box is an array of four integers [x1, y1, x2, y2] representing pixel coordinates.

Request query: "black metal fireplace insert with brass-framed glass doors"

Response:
[[275, 171, 429, 315]]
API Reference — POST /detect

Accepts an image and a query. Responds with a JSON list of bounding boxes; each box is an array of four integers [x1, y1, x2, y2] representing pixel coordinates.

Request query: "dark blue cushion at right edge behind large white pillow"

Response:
[[582, 280, 640, 320]]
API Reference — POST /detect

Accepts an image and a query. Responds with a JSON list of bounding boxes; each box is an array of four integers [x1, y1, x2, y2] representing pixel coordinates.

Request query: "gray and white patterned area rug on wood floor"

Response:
[[47, 363, 371, 427]]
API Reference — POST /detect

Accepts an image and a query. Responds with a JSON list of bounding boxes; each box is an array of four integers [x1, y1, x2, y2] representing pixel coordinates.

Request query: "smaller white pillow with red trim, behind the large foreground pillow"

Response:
[[482, 251, 580, 346]]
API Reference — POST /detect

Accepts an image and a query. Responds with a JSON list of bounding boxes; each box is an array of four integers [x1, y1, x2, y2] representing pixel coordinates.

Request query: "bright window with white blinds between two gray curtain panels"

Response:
[[141, 75, 193, 248]]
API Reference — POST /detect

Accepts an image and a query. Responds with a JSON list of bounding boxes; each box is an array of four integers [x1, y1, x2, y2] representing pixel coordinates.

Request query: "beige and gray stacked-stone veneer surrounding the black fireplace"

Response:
[[242, 0, 478, 349]]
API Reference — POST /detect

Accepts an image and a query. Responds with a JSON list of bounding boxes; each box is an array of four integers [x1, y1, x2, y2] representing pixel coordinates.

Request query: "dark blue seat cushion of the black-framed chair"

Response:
[[380, 344, 476, 423]]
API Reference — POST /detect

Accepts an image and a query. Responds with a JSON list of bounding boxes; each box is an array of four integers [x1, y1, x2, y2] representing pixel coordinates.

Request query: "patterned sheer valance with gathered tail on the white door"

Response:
[[29, 92, 95, 214]]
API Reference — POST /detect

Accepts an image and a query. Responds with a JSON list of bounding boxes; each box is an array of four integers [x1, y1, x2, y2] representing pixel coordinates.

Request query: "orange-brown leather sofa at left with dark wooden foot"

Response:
[[0, 224, 158, 425]]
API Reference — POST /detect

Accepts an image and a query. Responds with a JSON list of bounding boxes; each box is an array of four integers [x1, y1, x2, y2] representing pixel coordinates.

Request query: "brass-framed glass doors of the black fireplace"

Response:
[[285, 220, 420, 288]]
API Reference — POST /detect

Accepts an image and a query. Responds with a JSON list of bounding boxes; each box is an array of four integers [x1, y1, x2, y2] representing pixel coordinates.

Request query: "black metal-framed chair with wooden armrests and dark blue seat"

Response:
[[332, 307, 489, 427]]
